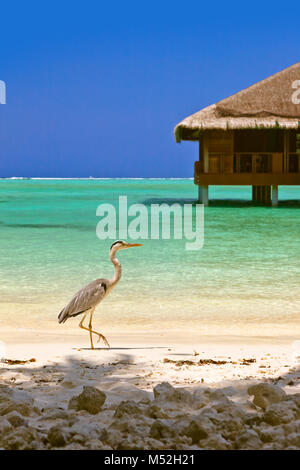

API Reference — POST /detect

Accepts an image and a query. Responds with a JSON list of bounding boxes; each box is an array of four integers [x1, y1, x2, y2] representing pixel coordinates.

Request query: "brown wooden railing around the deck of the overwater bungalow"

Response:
[[195, 152, 300, 175]]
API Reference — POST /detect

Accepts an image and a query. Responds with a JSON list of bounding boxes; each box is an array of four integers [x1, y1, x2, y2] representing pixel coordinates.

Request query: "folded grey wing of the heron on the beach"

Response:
[[58, 279, 107, 323]]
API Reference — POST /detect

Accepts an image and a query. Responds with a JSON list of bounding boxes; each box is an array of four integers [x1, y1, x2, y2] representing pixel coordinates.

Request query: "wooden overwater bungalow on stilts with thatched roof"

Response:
[[175, 62, 300, 206]]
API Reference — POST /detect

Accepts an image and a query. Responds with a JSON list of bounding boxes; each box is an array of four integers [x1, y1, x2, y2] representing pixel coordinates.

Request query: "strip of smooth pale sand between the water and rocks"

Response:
[[0, 330, 300, 388]]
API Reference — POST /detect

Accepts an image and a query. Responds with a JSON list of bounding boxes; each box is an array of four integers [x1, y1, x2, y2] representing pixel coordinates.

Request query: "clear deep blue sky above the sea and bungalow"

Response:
[[0, 0, 300, 177]]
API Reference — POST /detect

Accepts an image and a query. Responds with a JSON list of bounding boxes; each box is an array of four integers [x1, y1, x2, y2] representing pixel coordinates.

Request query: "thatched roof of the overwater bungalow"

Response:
[[174, 62, 300, 142]]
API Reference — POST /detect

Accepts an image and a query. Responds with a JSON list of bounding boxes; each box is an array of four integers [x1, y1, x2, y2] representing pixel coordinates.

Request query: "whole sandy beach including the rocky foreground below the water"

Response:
[[0, 330, 300, 449]]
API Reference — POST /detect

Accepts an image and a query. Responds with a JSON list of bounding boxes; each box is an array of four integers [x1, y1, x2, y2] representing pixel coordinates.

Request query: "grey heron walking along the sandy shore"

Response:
[[58, 240, 143, 349]]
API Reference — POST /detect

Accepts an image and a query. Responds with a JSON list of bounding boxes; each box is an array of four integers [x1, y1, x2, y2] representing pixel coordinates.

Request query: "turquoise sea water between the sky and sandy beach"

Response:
[[0, 179, 300, 335]]
